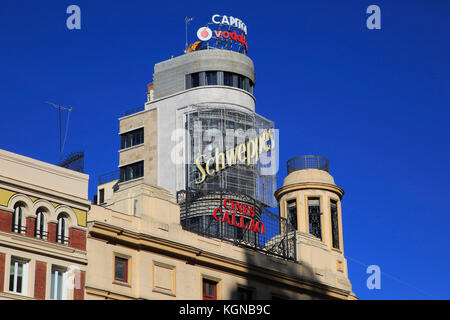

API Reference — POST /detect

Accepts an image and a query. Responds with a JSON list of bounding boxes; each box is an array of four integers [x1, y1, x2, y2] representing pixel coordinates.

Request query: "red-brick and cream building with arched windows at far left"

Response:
[[0, 150, 91, 300]]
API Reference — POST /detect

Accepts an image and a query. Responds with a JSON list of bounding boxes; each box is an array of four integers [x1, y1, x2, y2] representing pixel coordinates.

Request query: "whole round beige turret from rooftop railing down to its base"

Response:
[[275, 155, 351, 290]]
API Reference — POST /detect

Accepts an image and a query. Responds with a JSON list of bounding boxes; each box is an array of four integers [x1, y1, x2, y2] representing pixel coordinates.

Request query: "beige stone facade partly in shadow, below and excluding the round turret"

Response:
[[86, 182, 355, 300]]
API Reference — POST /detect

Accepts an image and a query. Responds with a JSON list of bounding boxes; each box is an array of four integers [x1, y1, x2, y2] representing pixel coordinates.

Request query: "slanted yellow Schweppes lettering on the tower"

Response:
[[195, 129, 275, 184]]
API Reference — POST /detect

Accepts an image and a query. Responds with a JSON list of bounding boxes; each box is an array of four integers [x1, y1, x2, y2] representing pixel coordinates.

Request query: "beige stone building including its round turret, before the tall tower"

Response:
[[86, 159, 356, 300]]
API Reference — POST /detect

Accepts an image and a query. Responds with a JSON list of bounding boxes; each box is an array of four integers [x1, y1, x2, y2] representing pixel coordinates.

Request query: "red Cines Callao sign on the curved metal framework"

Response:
[[213, 199, 266, 234]]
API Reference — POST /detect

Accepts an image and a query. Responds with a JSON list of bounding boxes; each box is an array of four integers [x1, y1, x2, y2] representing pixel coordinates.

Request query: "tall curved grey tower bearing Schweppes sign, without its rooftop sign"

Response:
[[111, 48, 276, 242]]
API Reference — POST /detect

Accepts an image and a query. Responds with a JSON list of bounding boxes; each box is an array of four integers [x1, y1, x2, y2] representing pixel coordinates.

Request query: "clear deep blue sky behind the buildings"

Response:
[[0, 0, 450, 299]]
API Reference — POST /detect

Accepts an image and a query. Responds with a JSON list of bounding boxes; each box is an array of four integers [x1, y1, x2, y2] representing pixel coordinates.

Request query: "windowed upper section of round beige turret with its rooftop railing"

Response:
[[275, 155, 344, 252]]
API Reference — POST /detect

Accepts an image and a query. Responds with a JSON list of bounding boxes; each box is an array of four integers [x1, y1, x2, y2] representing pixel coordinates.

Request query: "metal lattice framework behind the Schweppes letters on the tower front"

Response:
[[185, 104, 277, 207]]
